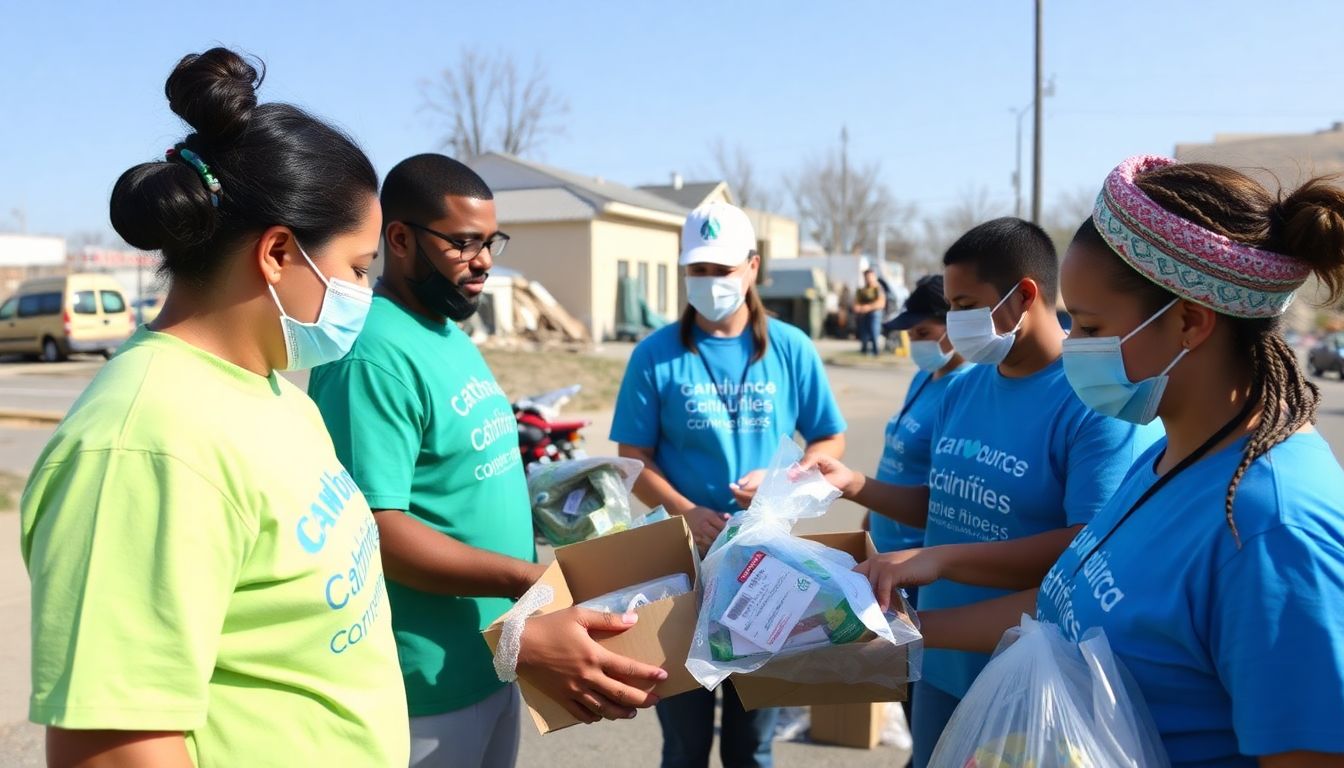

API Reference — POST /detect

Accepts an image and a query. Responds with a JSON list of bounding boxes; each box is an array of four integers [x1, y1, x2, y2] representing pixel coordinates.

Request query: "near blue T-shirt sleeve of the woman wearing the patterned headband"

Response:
[[1210, 526, 1344, 756]]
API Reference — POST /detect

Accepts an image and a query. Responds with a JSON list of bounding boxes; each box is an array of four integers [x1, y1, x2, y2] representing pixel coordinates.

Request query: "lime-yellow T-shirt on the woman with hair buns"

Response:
[[22, 328, 410, 767]]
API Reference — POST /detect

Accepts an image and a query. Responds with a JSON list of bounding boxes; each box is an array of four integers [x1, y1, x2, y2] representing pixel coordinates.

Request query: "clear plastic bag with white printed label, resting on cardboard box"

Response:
[[687, 440, 922, 689]]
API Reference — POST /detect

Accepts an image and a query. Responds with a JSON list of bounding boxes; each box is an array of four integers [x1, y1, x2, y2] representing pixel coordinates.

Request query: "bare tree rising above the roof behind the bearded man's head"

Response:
[[421, 50, 569, 159]]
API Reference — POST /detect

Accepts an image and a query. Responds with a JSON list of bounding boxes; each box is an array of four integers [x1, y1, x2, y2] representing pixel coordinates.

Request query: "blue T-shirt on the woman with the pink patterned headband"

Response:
[[1038, 433, 1344, 768]]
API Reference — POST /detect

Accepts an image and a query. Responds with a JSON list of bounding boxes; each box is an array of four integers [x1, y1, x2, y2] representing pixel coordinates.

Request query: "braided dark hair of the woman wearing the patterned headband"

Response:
[[1074, 163, 1344, 546]]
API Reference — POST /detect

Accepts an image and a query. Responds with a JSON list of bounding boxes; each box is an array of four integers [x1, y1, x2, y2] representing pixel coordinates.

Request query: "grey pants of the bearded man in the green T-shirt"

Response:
[[411, 685, 523, 768]]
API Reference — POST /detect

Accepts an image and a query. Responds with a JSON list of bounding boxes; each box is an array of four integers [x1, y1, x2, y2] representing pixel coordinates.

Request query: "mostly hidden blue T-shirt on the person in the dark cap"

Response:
[[868, 363, 970, 551]]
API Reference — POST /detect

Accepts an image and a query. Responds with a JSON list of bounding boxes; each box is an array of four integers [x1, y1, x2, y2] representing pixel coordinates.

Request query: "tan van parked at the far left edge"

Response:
[[0, 273, 136, 362]]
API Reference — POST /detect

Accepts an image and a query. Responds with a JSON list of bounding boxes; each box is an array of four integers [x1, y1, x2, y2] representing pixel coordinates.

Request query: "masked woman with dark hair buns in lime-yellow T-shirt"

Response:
[[22, 48, 409, 767]]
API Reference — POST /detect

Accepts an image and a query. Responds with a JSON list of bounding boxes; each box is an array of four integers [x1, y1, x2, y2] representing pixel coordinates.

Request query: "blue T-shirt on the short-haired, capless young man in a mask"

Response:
[[919, 359, 1161, 697]]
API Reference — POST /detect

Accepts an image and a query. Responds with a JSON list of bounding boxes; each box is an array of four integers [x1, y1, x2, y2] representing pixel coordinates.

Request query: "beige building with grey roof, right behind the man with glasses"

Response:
[[470, 153, 688, 340]]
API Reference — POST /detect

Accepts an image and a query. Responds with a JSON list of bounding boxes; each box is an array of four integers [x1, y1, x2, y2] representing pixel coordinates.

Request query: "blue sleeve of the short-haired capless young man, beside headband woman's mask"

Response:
[[1060, 404, 1146, 526]]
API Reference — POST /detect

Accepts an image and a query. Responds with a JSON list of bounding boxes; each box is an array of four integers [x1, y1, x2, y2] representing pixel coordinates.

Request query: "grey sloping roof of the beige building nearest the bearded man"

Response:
[[469, 152, 687, 226]]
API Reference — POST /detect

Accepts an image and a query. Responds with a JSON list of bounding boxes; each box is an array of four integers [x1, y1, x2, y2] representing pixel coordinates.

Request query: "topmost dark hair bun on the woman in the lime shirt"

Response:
[[164, 48, 265, 143]]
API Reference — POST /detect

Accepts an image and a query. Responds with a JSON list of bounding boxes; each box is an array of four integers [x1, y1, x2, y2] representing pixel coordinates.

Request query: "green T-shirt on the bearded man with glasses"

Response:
[[308, 296, 536, 717]]
